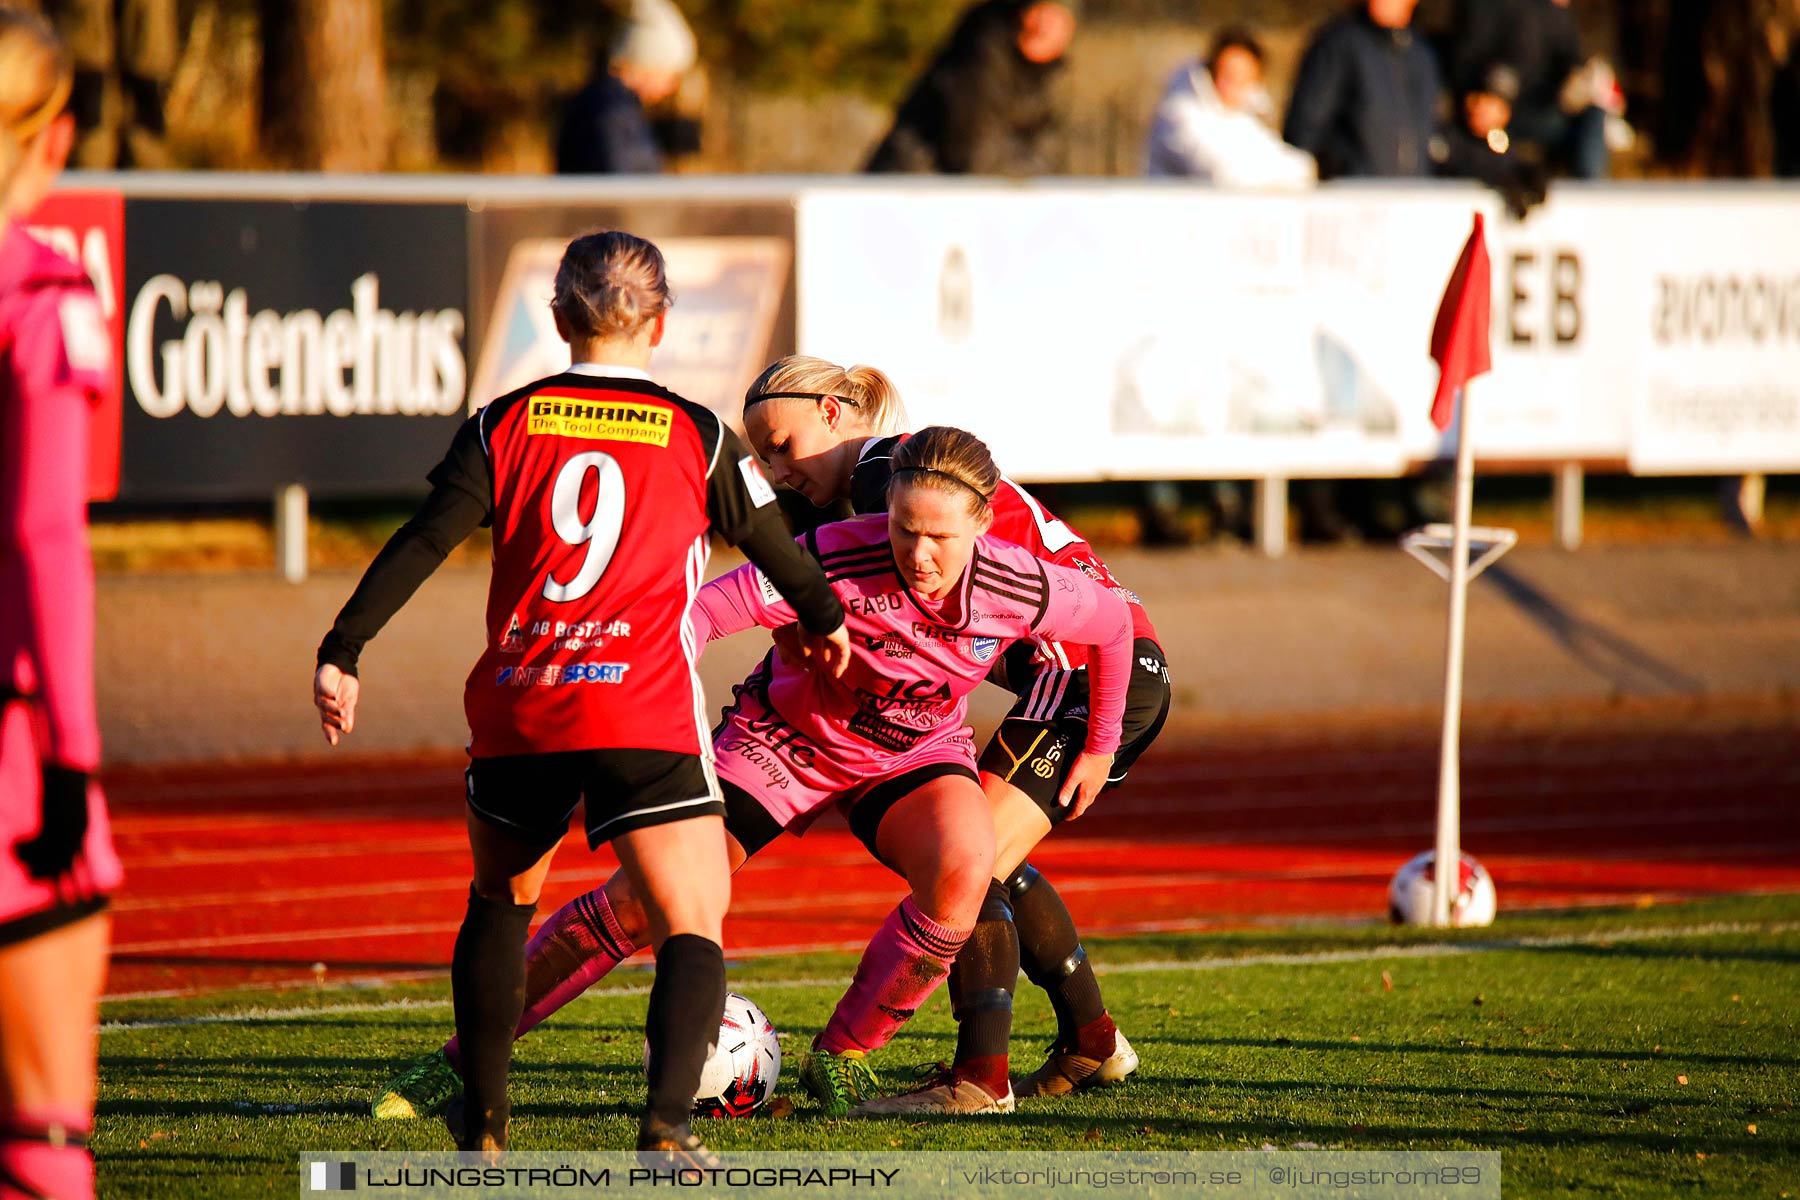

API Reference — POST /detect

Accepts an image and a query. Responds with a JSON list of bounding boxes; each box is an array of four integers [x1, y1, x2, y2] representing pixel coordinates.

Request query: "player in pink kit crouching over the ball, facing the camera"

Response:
[[376, 430, 1130, 1117]]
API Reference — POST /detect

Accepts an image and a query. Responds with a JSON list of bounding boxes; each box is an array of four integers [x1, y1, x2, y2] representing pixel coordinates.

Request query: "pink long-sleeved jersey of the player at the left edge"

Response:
[[0, 290, 101, 770]]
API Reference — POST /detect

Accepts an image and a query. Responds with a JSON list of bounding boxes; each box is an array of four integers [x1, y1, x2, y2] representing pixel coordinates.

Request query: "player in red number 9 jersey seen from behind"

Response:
[[313, 230, 848, 1162]]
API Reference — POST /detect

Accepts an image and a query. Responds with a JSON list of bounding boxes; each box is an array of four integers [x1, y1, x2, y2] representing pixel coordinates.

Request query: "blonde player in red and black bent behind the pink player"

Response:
[[743, 358, 1170, 1108]]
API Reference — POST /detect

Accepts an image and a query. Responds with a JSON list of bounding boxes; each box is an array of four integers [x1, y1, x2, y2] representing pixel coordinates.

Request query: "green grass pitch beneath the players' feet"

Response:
[[94, 896, 1800, 1200]]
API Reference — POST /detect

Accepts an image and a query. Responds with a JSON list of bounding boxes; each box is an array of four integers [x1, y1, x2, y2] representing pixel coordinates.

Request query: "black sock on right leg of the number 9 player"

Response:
[[644, 934, 725, 1126]]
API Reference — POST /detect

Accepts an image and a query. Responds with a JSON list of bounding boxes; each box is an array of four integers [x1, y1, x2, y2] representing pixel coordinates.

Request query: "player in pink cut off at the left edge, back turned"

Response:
[[0, 11, 122, 1198]]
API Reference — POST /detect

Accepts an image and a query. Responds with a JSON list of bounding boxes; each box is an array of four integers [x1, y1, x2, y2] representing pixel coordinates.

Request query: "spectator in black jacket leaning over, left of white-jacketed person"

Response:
[[868, 0, 1076, 176]]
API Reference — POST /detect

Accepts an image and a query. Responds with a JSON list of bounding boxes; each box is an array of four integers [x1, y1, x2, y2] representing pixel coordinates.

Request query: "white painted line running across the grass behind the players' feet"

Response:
[[99, 921, 1800, 1034]]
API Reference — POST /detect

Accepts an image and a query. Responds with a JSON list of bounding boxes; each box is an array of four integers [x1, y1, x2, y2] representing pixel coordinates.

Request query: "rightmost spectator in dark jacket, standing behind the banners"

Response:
[[1445, 0, 1624, 180]]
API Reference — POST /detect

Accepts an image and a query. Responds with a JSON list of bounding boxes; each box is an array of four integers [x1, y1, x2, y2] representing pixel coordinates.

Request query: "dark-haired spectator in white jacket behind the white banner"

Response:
[[1147, 29, 1318, 187]]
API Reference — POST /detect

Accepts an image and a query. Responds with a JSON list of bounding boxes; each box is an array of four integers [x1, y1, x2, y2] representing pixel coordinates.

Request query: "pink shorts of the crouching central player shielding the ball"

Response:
[[713, 687, 976, 837]]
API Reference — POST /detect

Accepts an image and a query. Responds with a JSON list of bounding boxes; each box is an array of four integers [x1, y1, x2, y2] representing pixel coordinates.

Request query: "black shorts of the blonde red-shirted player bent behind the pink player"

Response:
[[981, 637, 1170, 824]]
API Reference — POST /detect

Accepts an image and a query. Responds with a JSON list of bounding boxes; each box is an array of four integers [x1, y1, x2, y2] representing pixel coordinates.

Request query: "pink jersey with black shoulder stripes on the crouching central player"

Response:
[[693, 515, 1132, 772]]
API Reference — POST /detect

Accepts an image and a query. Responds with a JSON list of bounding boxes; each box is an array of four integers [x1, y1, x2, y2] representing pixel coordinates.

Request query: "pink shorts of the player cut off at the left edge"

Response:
[[0, 703, 124, 945]]
